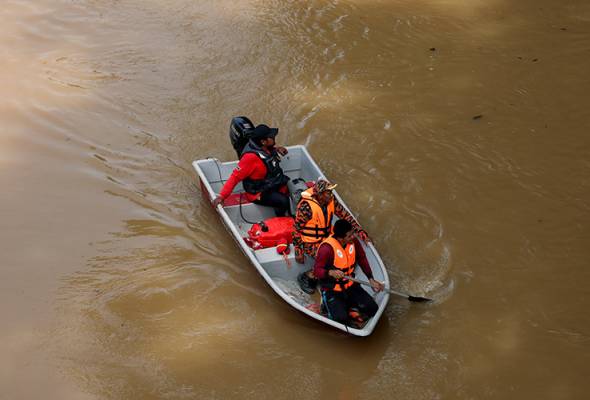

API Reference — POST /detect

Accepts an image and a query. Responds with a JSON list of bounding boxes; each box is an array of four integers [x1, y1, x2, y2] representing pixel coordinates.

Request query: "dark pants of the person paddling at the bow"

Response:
[[322, 283, 379, 324]]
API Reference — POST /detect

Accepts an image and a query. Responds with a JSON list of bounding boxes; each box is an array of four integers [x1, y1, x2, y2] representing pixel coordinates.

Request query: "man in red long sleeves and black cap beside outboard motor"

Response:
[[213, 124, 289, 217]]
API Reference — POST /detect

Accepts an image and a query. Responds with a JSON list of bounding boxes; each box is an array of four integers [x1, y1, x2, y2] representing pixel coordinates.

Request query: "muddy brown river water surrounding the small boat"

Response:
[[0, 0, 590, 400]]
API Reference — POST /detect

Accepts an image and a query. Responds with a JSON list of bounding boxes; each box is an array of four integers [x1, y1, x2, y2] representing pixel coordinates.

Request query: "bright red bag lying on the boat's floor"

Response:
[[244, 217, 295, 250]]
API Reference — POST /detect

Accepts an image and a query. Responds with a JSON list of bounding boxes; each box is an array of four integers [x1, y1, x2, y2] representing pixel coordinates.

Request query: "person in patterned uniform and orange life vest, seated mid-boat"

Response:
[[293, 179, 371, 294]]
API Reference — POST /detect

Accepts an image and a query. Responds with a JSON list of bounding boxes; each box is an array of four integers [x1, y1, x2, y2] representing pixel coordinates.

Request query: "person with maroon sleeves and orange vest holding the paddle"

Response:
[[313, 219, 384, 325]]
